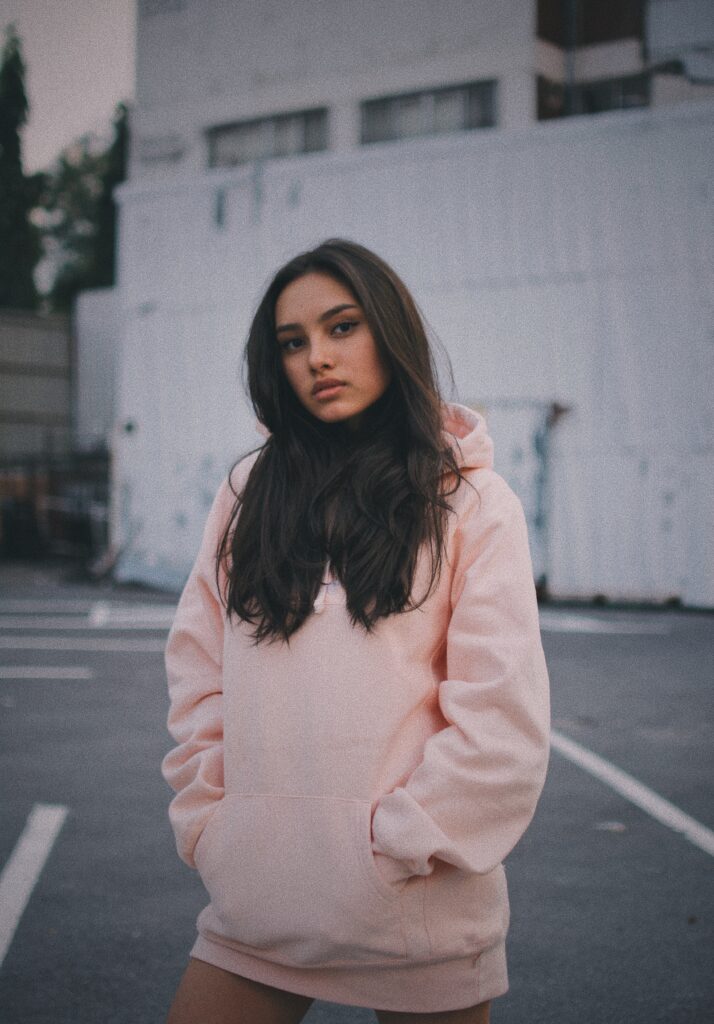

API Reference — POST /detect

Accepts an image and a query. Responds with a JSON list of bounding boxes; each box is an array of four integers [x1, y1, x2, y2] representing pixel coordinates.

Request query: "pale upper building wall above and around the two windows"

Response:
[[130, 0, 535, 180]]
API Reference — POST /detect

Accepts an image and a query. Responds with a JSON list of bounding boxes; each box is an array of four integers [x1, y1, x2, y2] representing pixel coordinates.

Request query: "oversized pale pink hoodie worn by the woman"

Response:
[[163, 403, 549, 1013]]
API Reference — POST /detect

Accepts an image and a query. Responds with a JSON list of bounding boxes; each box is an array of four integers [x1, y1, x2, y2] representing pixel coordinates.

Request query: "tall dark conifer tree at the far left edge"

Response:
[[0, 25, 44, 309]]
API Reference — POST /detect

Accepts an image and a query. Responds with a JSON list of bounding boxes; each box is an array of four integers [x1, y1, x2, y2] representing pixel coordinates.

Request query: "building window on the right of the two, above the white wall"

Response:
[[362, 81, 496, 143]]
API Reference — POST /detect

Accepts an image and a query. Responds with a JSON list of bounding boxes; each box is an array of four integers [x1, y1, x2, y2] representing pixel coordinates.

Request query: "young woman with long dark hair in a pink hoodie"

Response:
[[163, 239, 549, 1024]]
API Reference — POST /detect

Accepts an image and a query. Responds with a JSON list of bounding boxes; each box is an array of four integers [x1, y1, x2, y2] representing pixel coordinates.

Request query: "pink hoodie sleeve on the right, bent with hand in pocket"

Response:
[[373, 470, 550, 881]]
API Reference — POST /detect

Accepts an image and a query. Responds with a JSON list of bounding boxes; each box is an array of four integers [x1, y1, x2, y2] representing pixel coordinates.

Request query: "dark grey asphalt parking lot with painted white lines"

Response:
[[0, 563, 714, 1024]]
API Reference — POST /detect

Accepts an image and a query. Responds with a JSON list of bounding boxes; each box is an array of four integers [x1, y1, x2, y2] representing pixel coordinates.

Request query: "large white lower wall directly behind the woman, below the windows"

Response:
[[115, 103, 714, 605]]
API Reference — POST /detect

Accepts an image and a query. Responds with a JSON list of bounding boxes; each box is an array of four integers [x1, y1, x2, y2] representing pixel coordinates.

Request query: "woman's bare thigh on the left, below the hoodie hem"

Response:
[[166, 957, 312, 1024]]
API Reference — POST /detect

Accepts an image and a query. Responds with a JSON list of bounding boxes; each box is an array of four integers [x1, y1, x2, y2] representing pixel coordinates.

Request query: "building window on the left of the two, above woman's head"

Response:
[[208, 108, 327, 167]]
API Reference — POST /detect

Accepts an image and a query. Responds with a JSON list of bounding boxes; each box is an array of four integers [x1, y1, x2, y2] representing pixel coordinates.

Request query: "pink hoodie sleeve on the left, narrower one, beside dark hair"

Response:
[[161, 480, 234, 867]]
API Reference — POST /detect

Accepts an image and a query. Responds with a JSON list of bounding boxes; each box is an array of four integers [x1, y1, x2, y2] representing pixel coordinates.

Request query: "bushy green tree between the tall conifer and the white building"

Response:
[[40, 103, 127, 310]]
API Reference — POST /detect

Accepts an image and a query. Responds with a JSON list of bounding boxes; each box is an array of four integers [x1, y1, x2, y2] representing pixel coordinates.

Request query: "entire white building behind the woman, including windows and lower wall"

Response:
[[114, 0, 714, 605]]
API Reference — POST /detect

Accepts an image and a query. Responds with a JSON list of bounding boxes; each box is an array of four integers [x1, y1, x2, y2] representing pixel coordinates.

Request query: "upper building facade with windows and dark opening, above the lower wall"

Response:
[[130, 0, 714, 181]]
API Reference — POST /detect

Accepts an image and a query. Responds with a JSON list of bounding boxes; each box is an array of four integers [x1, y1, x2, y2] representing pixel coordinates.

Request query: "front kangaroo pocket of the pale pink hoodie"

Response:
[[196, 794, 407, 966]]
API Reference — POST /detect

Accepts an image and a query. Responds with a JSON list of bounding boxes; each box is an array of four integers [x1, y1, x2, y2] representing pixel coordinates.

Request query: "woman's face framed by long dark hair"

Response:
[[276, 271, 391, 429]]
